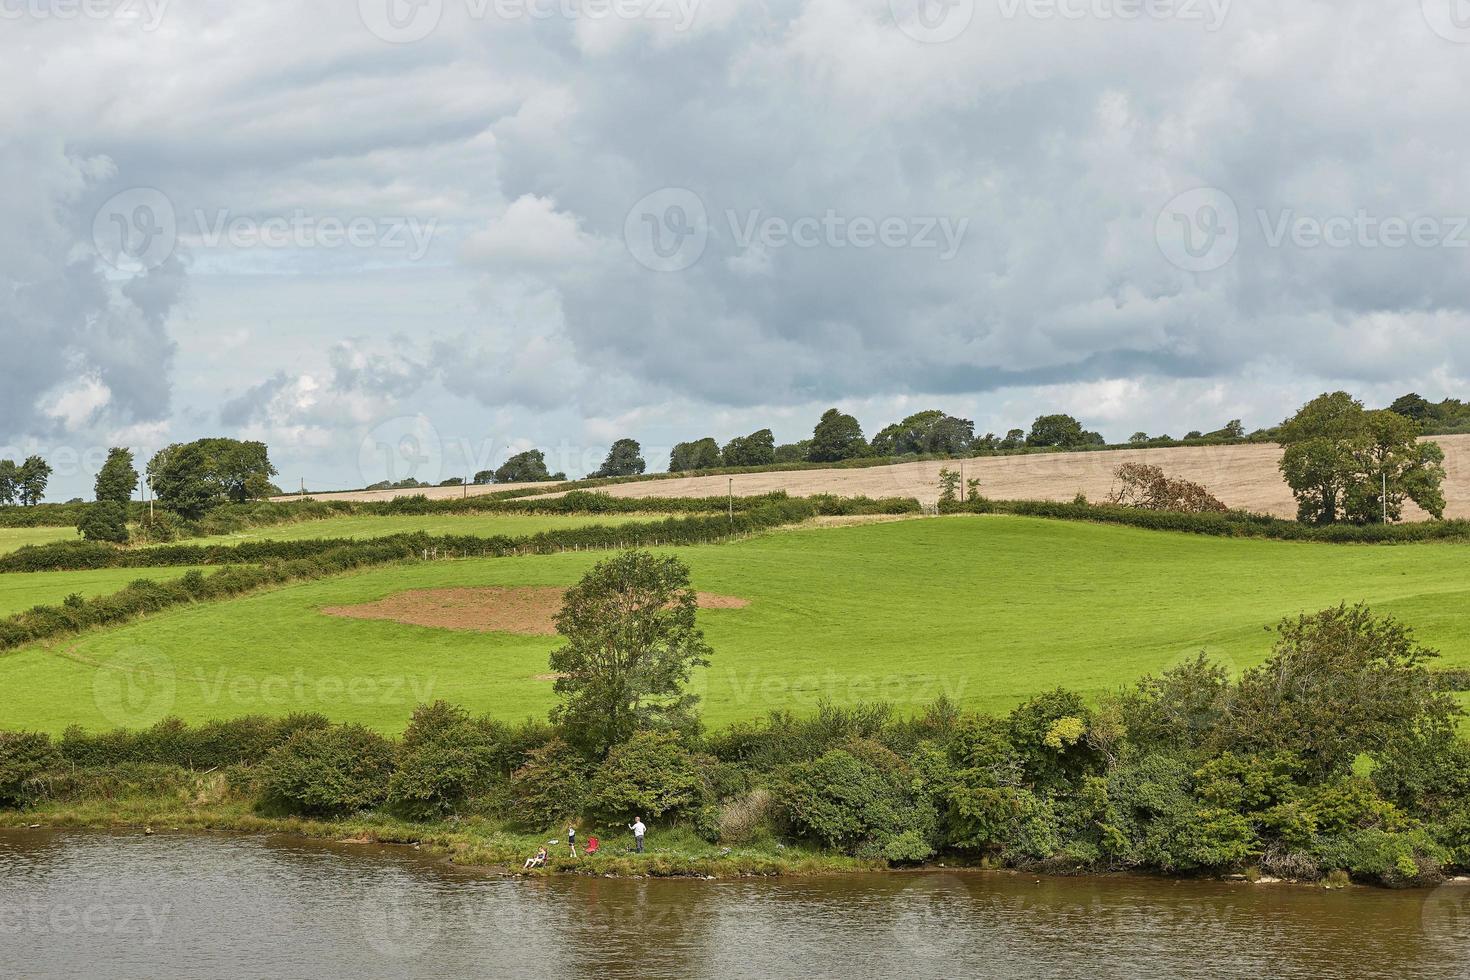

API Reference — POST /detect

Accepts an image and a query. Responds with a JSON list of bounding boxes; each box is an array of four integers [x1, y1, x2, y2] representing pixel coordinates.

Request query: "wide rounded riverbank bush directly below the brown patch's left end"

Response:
[[260, 724, 394, 817]]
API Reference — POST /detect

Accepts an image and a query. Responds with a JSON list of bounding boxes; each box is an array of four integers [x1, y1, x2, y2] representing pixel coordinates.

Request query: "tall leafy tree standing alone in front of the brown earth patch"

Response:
[[551, 551, 710, 755]]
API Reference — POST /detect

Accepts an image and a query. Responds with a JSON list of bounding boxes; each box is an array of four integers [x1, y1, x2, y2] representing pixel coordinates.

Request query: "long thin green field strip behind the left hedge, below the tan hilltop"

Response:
[[168, 514, 659, 545]]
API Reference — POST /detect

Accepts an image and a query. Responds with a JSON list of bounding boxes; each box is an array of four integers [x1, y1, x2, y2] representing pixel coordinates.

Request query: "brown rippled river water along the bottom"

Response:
[[0, 832, 1470, 980]]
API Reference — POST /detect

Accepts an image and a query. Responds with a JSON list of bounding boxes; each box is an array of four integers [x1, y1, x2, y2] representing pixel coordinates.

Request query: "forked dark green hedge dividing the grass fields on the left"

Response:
[[0, 500, 817, 649]]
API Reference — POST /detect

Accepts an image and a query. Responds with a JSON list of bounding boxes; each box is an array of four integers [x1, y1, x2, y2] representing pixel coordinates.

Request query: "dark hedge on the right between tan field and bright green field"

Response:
[[941, 498, 1470, 544]]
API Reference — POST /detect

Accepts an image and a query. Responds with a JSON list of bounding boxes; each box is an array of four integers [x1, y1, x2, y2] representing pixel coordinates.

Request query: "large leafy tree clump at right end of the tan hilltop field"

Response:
[[1276, 391, 1445, 525]]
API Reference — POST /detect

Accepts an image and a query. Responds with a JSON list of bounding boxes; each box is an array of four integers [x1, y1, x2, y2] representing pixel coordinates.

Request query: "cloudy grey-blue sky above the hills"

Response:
[[0, 0, 1470, 500]]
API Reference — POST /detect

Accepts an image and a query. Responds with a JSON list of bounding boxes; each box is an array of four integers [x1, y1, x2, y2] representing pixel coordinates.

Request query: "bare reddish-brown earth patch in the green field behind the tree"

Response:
[[322, 585, 750, 636]]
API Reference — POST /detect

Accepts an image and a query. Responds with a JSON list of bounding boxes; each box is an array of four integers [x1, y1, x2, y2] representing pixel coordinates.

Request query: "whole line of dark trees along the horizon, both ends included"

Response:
[[0, 391, 1470, 531]]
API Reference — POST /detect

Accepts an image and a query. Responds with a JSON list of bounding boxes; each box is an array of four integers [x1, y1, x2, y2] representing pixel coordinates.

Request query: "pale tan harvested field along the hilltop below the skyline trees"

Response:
[[276, 435, 1470, 520]]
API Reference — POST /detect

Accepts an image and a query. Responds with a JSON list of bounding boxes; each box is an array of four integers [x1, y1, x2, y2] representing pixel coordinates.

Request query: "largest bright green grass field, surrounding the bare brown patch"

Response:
[[0, 517, 1470, 732]]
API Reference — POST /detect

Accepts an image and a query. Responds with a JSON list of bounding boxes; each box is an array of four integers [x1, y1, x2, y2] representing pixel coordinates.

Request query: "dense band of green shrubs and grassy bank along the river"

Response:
[[0, 607, 1470, 886]]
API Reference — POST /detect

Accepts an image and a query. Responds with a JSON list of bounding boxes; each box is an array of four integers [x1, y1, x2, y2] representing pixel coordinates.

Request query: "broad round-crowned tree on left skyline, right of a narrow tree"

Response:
[[148, 438, 279, 517]]
